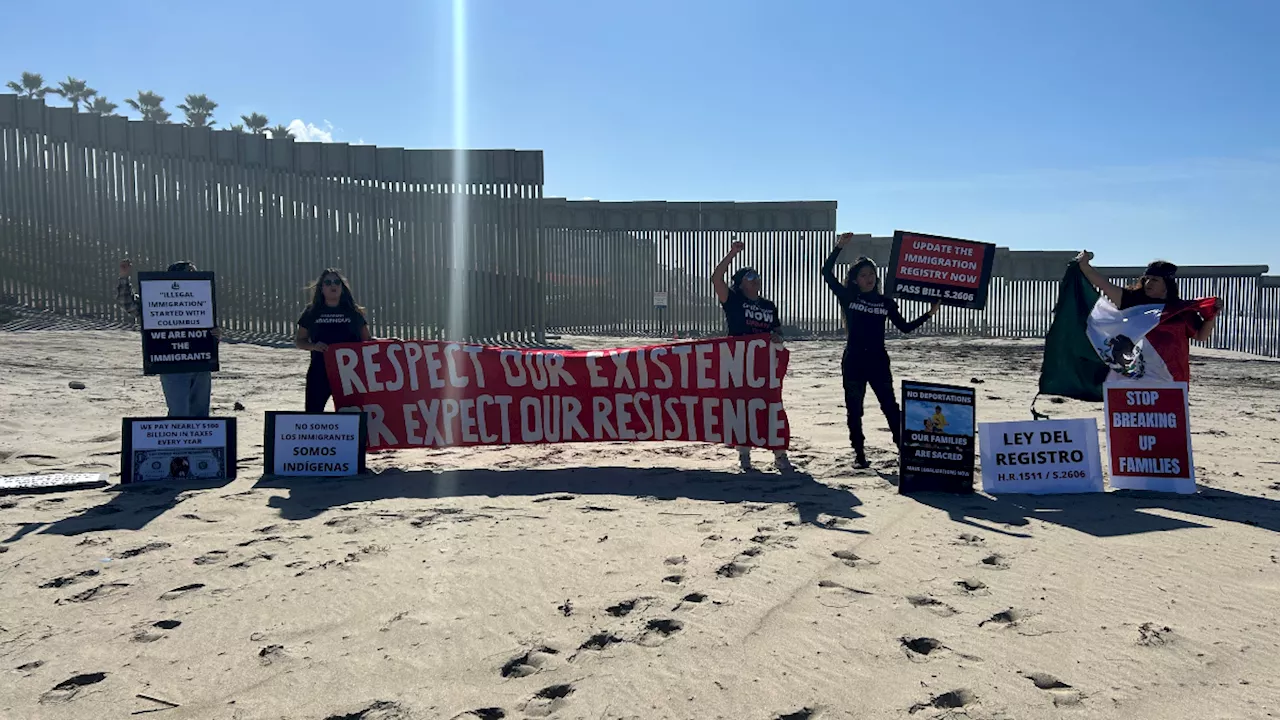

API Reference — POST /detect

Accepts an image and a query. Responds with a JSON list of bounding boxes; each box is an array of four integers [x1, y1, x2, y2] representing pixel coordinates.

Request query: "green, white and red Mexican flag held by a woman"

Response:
[[1039, 263, 1215, 402]]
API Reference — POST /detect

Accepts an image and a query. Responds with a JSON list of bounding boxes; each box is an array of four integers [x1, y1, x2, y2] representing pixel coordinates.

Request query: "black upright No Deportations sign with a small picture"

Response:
[[897, 380, 975, 495]]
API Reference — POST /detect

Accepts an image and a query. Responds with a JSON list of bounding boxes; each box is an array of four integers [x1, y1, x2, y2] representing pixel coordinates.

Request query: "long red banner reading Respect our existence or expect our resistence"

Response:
[[325, 336, 790, 450]]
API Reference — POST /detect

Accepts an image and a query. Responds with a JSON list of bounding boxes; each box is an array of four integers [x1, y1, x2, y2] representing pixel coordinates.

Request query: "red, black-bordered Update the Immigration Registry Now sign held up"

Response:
[[884, 231, 996, 310]]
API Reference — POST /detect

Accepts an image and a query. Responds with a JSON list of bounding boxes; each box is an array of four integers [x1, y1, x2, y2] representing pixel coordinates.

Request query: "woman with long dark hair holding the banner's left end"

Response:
[[293, 268, 374, 413]]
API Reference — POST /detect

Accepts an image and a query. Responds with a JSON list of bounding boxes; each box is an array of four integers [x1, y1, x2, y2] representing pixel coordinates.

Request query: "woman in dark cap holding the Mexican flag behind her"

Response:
[[1075, 250, 1222, 383]]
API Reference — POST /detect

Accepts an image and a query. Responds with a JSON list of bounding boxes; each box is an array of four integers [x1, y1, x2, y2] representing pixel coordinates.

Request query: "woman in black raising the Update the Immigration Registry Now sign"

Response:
[[822, 233, 938, 468]]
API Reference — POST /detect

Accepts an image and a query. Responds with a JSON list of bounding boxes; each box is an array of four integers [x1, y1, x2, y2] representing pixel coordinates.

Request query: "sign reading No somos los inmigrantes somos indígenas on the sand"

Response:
[[262, 413, 367, 478]]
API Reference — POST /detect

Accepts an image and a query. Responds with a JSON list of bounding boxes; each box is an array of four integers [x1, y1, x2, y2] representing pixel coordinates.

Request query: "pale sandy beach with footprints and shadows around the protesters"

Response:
[[0, 316, 1280, 720]]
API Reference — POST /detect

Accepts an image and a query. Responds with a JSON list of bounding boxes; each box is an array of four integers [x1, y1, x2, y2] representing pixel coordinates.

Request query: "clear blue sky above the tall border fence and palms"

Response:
[[0, 0, 1280, 272]]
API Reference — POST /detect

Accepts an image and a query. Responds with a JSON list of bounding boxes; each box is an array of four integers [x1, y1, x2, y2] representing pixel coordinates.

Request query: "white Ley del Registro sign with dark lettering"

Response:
[[978, 418, 1103, 495]]
